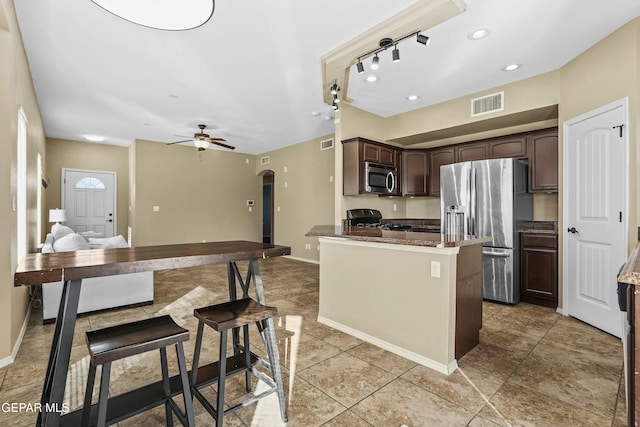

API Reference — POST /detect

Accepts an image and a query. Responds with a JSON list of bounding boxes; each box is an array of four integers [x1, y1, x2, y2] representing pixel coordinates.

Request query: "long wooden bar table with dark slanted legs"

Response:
[[14, 241, 291, 426]]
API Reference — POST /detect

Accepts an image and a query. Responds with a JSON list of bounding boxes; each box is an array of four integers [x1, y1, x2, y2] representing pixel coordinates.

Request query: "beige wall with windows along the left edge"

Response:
[[0, 0, 45, 365]]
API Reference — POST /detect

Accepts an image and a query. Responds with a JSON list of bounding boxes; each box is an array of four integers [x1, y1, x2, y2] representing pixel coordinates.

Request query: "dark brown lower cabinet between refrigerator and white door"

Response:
[[520, 233, 558, 308]]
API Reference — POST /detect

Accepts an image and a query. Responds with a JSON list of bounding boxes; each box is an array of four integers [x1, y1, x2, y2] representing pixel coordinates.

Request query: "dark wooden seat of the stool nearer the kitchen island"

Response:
[[193, 298, 278, 332]]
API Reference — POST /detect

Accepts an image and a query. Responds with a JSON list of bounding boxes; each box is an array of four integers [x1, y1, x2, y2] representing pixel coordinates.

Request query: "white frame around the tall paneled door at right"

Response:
[[558, 97, 631, 316]]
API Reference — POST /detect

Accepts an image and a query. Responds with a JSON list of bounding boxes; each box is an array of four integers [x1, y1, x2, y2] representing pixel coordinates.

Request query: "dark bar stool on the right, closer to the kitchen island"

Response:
[[191, 298, 286, 427]]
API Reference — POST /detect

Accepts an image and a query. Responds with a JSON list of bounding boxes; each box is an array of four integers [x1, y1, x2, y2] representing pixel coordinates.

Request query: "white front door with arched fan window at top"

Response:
[[62, 169, 116, 237]]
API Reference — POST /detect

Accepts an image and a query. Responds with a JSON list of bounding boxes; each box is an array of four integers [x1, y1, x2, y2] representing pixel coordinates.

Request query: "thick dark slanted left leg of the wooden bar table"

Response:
[[36, 279, 82, 426]]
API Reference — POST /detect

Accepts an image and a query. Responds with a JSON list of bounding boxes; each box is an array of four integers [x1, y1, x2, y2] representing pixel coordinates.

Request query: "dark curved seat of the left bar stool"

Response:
[[86, 315, 189, 365]]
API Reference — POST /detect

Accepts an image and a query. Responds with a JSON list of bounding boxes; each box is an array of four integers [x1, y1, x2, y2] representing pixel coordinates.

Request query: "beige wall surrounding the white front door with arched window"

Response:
[[43, 138, 129, 238]]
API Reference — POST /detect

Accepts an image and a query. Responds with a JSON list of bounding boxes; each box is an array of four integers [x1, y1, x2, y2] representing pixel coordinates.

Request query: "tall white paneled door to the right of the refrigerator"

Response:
[[563, 99, 628, 337]]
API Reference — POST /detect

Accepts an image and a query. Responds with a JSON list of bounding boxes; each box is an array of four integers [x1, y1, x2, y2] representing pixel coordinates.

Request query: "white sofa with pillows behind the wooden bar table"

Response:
[[42, 224, 153, 322]]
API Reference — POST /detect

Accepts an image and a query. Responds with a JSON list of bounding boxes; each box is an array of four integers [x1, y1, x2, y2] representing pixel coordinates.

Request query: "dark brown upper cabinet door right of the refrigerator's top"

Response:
[[527, 130, 558, 191]]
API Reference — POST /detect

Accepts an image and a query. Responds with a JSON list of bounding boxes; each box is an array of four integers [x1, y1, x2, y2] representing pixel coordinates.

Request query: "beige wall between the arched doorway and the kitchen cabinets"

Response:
[[256, 135, 342, 261]]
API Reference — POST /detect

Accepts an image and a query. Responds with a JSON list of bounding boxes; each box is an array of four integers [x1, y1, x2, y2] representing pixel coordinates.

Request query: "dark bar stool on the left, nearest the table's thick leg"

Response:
[[82, 315, 195, 426]]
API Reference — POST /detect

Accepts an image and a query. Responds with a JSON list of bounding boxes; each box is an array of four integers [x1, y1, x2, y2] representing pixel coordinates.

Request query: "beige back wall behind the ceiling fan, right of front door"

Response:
[[130, 140, 262, 246]]
